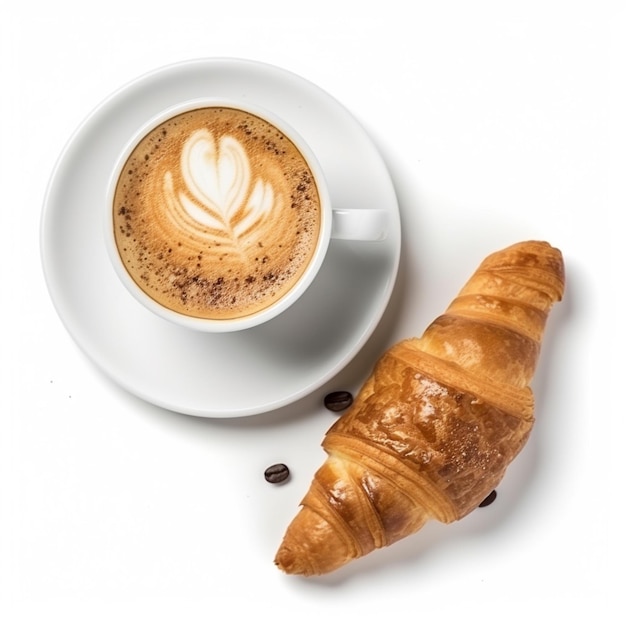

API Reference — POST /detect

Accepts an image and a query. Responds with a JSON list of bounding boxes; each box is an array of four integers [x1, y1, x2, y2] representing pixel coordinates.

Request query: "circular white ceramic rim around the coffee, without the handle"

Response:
[[104, 97, 332, 333]]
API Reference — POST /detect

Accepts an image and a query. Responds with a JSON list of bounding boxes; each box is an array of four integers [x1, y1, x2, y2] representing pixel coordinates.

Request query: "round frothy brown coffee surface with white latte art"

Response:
[[112, 107, 322, 320]]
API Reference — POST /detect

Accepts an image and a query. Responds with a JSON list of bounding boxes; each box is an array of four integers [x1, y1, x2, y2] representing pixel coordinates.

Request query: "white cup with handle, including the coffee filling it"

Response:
[[104, 98, 388, 332]]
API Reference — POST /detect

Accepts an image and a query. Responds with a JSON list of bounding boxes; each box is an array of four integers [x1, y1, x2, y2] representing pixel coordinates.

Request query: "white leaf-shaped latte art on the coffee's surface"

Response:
[[164, 129, 282, 254]]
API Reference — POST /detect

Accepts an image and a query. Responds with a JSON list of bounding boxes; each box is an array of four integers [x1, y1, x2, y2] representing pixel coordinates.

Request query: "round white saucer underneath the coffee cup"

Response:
[[41, 59, 400, 417]]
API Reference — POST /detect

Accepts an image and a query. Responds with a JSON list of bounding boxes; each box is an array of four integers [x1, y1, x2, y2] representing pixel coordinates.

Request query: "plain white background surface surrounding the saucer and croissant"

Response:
[[0, 0, 626, 626]]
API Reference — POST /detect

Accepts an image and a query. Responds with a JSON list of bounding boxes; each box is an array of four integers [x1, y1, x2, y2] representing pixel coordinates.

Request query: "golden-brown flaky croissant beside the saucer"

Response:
[[275, 241, 565, 576]]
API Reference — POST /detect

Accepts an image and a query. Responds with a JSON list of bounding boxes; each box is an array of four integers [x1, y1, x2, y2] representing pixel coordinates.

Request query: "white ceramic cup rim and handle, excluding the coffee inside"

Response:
[[104, 98, 389, 332]]
